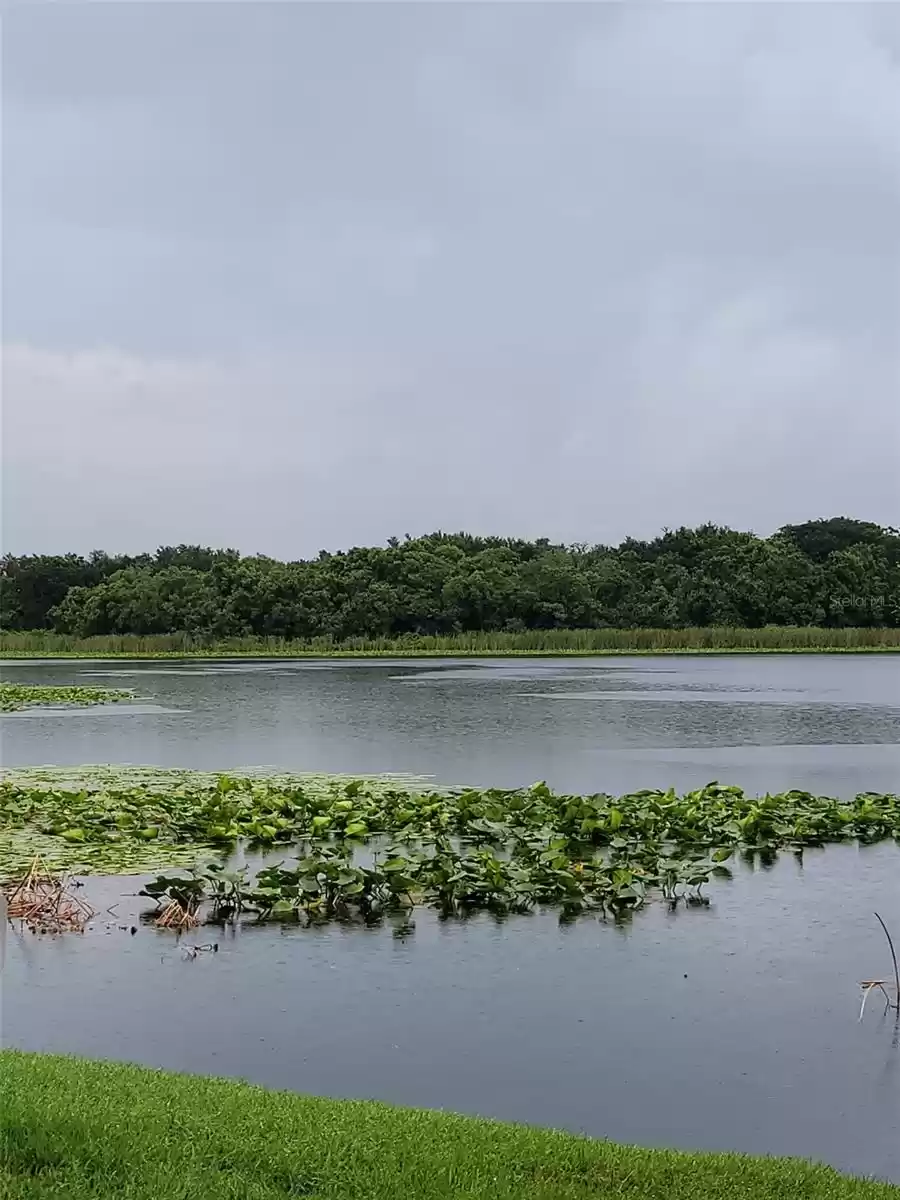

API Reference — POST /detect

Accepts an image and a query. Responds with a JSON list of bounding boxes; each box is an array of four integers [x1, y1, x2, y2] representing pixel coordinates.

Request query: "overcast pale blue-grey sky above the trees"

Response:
[[2, 2, 900, 557]]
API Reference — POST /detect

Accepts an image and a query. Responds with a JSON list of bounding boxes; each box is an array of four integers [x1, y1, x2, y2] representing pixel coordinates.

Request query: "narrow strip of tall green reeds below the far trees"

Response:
[[0, 625, 900, 659]]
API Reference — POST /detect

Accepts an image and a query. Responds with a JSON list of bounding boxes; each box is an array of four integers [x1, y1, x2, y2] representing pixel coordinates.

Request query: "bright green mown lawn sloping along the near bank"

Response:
[[0, 1056, 900, 1200]]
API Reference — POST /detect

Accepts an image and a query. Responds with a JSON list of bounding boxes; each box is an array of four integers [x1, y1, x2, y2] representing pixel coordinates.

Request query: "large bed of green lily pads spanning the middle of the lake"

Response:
[[0, 767, 900, 920]]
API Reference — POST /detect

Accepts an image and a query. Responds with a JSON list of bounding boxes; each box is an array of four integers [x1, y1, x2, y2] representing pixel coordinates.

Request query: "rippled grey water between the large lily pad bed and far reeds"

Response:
[[2, 655, 900, 794]]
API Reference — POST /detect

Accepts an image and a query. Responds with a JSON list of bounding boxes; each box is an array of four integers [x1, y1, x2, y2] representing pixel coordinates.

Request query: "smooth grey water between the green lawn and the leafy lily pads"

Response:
[[4, 845, 900, 1182]]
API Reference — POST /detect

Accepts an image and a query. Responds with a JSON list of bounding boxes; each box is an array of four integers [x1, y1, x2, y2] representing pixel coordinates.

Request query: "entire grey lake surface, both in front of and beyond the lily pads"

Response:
[[2, 658, 900, 1182]]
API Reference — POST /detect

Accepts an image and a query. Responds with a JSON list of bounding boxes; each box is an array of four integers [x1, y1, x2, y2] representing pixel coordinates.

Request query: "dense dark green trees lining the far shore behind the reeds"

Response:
[[0, 517, 900, 641]]
